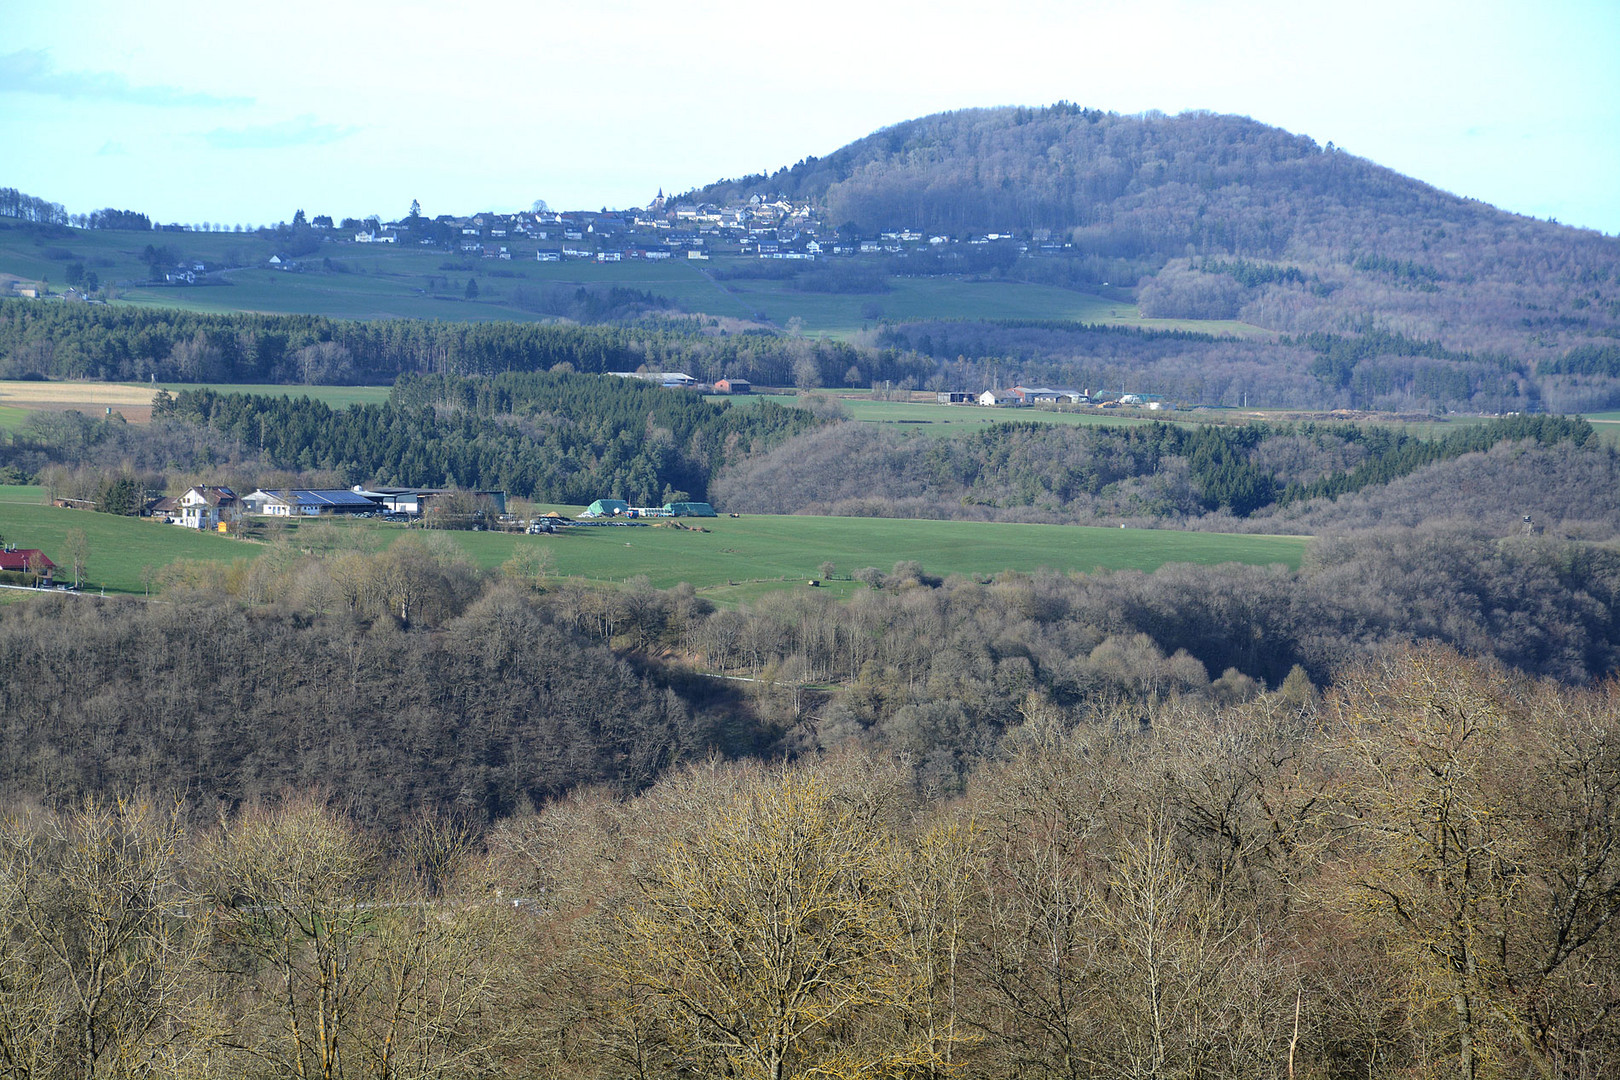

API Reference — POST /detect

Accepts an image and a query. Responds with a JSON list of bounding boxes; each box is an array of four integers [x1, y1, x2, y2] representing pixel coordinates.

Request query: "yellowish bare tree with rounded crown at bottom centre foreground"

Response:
[[604, 771, 943, 1080]]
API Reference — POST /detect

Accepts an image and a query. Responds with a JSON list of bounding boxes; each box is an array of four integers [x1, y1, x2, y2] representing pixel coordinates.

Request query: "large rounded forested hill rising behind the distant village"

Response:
[[695, 104, 1620, 359]]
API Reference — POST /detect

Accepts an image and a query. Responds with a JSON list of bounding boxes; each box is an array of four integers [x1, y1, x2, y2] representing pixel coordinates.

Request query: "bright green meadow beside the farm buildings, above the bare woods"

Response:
[[0, 487, 1307, 601]]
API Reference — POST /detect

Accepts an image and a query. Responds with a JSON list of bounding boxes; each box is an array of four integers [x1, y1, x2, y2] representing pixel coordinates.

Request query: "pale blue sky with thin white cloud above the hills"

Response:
[[0, 0, 1620, 235]]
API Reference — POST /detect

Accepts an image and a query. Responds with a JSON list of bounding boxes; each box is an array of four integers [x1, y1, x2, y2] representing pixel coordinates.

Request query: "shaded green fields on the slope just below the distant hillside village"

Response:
[[0, 227, 1268, 337]]
